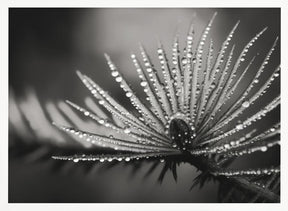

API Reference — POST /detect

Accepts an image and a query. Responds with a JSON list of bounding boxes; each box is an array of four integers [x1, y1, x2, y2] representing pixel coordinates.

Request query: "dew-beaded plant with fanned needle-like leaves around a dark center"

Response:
[[11, 13, 280, 202]]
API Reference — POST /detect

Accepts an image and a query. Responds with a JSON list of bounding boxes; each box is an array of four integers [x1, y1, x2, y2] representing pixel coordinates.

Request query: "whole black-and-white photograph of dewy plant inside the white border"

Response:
[[8, 5, 280, 203]]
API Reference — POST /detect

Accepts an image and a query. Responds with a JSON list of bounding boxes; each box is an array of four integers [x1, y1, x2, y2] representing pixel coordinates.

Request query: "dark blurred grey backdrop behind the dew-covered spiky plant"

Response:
[[9, 8, 280, 202]]
